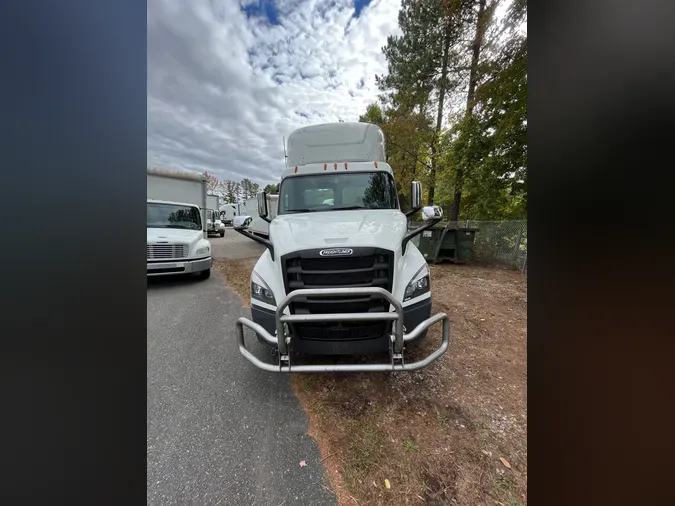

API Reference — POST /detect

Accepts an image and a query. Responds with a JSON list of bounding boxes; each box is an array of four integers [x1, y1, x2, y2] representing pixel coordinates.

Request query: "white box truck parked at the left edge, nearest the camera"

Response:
[[147, 168, 211, 279]]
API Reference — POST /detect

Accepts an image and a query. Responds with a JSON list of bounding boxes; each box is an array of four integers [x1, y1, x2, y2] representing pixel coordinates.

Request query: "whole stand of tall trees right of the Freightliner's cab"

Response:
[[370, 0, 527, 220]]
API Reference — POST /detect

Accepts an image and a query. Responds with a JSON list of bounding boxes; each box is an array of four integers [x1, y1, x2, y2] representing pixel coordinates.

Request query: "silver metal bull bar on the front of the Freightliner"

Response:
[[237, 287, 450, 372]]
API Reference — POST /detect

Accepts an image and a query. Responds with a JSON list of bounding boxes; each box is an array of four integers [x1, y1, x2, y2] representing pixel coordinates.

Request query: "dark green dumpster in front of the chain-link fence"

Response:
[[411, 223, 478, 263]]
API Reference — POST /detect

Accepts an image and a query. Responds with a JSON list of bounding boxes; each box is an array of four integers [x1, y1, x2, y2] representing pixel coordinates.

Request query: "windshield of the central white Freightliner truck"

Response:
[[279, 172, 398, 214]]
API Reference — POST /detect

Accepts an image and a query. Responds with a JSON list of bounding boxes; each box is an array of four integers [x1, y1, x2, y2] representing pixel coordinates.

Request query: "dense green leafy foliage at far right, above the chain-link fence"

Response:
[[441, 5, 527, 220]]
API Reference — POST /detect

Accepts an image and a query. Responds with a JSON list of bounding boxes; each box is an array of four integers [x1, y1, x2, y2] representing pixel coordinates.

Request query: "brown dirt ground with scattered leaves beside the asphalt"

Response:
[[217, 260, 527, 506]]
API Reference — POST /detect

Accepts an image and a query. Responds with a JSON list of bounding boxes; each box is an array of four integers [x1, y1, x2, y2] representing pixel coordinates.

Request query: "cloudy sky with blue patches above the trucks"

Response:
[[148, 0, 400, 185]]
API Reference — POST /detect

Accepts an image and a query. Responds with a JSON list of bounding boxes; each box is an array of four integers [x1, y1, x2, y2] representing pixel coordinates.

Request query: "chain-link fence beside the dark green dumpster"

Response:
[[458, 220, 527, 272]]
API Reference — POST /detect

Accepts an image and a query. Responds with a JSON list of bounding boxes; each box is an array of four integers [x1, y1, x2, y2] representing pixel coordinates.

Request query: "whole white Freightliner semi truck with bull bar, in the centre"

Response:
[[235, 123, 450, 372]]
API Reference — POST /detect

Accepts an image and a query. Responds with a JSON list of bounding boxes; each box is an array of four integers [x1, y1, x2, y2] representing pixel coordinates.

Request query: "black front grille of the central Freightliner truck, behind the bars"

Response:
[[282, 248, 394, 340]]
